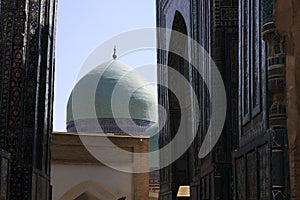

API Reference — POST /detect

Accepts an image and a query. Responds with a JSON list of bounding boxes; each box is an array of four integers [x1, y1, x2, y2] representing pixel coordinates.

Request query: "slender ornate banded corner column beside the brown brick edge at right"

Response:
[[262, 0, 289, 199]]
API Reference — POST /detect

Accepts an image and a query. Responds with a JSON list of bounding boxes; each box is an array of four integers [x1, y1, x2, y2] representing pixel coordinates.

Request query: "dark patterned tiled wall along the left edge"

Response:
[[0, 0, 56, 200]]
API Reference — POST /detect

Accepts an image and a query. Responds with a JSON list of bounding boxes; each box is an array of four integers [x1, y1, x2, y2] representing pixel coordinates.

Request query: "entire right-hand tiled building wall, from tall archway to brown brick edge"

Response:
[[157, 0, 300, 200]]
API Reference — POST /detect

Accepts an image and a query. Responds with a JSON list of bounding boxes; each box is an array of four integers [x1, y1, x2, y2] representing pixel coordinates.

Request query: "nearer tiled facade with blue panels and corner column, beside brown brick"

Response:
[[235, 0, 289, 199]]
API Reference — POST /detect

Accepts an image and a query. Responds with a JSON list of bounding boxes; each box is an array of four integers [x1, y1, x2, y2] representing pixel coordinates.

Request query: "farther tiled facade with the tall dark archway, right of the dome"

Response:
[[157, 0, 238, 199]]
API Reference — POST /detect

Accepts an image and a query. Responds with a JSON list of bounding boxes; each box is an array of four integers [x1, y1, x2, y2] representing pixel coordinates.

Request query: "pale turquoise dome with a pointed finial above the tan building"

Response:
[[67, 60, 156, 132]]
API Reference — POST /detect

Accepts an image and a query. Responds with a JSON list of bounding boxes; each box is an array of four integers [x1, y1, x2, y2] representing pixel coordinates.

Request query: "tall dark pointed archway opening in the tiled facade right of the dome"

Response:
[[168, 11, 192, 197]]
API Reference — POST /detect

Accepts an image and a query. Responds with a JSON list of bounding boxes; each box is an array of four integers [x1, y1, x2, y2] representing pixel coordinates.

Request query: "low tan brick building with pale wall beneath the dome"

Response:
[[51, 132, 149, 200]]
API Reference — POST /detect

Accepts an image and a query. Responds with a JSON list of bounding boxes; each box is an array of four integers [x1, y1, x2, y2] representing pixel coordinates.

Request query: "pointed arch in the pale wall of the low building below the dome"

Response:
[[59, 181, 117, 200]]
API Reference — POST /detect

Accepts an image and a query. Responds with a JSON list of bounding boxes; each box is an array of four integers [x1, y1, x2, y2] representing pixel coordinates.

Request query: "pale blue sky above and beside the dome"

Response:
[[53, 0, 155, 131]]
